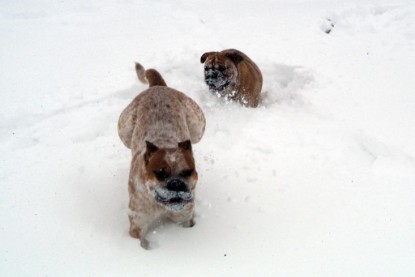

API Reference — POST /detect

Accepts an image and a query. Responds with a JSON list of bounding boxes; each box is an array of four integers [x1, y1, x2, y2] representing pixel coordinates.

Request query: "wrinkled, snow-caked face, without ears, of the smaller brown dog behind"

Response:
[[204, 54, 237, 94]]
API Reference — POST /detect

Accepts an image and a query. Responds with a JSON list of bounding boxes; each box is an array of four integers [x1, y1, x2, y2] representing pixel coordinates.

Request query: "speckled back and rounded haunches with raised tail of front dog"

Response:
[[118, 63, 206, 151]]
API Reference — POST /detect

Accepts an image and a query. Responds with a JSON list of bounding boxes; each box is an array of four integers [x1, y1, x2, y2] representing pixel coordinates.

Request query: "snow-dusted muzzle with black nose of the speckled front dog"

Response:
[[155, 179, 193, 212]]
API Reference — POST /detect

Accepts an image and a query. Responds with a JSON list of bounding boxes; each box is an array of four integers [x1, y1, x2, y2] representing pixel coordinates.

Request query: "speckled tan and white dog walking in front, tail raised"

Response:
[[118, 64, 206, 249]]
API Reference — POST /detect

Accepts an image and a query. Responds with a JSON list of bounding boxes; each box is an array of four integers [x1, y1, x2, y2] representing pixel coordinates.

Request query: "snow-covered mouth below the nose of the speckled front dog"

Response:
[[155, 188, 193, 212]]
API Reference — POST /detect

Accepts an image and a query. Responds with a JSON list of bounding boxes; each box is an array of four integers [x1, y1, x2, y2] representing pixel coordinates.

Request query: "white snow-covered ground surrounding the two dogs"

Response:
[[0, 0, 415, 276]]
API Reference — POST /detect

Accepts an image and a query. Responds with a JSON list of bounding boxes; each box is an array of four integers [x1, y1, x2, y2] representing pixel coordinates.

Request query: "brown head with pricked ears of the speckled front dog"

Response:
[[144, 140, 198, 212]]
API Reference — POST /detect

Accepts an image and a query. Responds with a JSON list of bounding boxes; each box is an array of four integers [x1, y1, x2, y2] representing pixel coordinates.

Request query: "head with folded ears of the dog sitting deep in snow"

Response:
[[200, 52, 243, 94]]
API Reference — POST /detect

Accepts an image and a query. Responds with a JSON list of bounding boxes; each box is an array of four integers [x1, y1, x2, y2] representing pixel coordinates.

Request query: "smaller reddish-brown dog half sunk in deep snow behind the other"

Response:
[[200, 49, 262, 107]]
